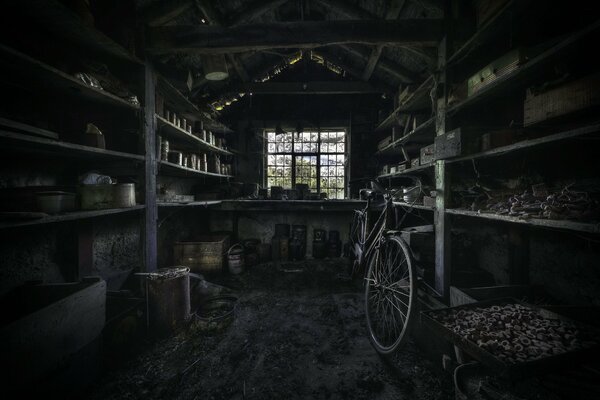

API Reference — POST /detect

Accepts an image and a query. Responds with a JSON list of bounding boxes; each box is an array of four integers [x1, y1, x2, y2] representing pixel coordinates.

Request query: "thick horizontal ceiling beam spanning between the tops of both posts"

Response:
[[147, 18, 444, 54]]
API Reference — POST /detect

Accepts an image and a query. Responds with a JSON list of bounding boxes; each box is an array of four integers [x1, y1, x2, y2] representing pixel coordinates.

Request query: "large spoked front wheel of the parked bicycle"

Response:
[[365, 235, 417, 354]]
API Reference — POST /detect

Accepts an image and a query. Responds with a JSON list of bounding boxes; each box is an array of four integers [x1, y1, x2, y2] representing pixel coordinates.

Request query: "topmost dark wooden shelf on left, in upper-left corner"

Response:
[[18, 0, 144, 68]]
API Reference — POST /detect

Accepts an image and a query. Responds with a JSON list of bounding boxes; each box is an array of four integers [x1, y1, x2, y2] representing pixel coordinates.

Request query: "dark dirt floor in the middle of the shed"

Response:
[[88, 261, 454, 399]]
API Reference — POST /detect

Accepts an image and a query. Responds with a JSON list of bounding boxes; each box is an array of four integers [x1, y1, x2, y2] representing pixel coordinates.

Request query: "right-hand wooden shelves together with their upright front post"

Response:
[[375, 8, 600, 298]]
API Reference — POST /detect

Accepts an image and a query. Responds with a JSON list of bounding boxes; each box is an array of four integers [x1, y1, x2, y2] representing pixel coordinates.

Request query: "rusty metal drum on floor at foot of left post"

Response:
[[146, 266, 190, 336]]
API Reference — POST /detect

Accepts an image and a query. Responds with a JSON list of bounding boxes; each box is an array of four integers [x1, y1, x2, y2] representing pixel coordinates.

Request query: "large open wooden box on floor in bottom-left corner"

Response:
[[0, 277, 106, 386]]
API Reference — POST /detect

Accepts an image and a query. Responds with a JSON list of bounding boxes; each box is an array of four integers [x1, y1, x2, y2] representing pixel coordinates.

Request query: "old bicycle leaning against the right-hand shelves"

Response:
[[350, 182, 418, 355]]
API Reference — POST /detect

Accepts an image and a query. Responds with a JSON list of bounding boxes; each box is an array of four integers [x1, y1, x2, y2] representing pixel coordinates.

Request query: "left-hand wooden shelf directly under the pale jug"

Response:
[[0, 129, 145, 162]]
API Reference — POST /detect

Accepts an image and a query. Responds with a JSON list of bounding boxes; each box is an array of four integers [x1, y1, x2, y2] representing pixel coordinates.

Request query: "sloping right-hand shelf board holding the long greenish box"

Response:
[[447, 21, 600, 116]]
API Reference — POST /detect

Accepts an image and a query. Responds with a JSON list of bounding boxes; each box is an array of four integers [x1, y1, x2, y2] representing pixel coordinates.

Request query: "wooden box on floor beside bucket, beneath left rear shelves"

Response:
[[173, 234, 229, 274]]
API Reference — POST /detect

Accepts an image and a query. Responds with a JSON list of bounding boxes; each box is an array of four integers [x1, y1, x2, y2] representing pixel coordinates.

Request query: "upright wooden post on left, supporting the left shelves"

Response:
[[143, 62, 158, 272]]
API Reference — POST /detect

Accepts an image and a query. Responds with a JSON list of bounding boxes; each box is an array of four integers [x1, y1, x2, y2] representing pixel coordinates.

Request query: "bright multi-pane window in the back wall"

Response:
[[266, 130, 347, 199]]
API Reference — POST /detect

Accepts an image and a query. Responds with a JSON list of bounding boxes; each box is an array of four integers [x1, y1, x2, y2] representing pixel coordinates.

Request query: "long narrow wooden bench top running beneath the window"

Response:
[[215, 200, 367, 212]]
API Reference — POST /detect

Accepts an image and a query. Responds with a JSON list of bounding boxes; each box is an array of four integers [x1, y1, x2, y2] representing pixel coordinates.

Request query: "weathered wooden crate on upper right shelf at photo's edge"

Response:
[[523, 73, 600, 126]]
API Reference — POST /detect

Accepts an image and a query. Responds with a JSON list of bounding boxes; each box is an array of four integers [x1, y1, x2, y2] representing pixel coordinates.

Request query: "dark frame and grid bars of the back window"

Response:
[[263, 127, 350, 200]]
